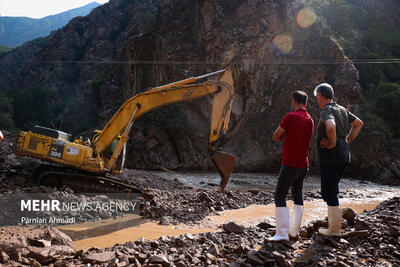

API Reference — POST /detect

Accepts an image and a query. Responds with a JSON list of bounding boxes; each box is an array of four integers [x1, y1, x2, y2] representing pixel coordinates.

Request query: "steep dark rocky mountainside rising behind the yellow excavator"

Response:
[[0, 0, 396, 180]]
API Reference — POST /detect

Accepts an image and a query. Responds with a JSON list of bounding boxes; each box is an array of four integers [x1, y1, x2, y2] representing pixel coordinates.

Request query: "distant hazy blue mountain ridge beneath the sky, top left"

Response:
[[0, 2, 100, 47]]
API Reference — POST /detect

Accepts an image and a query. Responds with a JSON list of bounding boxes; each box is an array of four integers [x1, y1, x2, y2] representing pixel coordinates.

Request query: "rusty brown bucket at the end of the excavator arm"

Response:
[[211, 151, 236, 192]]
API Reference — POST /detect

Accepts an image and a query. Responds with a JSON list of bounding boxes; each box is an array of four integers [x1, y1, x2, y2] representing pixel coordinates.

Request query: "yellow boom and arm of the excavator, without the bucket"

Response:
[[93, 71, 234, 153]]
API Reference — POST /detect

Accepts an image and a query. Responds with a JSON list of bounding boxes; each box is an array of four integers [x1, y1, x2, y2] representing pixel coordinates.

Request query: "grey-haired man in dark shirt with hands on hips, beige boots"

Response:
[[314, 83, 363, 236]]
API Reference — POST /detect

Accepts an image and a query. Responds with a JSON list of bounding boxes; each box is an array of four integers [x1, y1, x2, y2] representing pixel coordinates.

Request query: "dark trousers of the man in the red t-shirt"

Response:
[[275, 165, 307, 207]]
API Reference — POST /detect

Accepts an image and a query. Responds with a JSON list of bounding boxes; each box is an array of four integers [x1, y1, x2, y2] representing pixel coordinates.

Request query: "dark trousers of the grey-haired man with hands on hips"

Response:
[[320, 163, 347, 206]]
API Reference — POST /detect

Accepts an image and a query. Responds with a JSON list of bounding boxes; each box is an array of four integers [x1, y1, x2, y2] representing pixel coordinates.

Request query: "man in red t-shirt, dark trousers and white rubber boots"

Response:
[[269, 91, 314, 241]]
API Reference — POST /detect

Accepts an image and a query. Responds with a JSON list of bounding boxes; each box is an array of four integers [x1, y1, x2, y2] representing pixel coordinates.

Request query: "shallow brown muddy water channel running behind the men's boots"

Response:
[[58, 199, 382, 250]]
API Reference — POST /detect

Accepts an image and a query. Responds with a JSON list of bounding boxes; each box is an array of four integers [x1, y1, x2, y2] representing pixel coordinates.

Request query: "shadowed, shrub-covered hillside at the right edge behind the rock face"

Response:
[[305, 0, 400, 181]]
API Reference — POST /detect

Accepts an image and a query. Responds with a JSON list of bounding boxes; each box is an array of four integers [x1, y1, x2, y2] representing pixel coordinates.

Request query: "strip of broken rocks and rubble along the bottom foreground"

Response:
[[0, 197, 400, 267]]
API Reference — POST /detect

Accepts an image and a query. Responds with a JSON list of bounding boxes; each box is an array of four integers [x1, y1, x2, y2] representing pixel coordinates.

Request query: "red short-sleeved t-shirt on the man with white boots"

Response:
[[280, 108, 314, 168]]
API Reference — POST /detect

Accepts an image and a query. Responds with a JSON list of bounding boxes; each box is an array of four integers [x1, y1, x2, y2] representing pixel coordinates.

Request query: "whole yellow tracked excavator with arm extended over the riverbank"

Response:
[[14, 70, 235, 192]]
